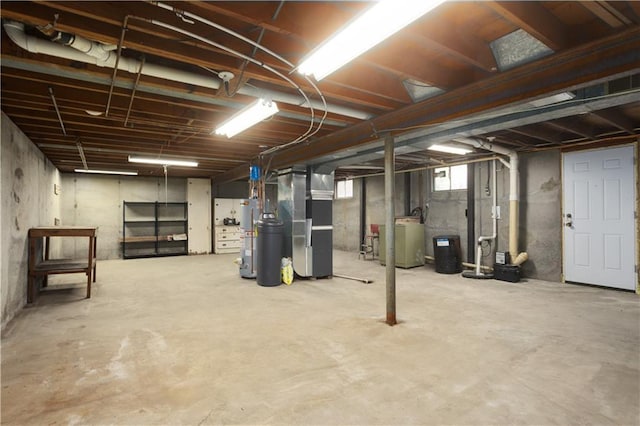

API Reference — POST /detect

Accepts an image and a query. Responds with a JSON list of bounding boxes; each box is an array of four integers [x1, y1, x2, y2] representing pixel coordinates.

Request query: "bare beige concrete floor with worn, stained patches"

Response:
[[2, 251, 640, 425]]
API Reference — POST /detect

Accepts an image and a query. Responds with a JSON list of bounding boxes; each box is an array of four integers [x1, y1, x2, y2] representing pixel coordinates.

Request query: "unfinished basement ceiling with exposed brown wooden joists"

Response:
[[0, 1, 640, 182]]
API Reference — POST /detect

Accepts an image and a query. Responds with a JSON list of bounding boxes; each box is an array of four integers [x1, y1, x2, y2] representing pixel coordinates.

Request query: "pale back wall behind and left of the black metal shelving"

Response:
[[61, 171, 187, 260]]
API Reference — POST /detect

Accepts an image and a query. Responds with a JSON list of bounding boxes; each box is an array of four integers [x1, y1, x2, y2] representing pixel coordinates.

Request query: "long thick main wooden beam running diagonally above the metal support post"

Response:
[[216, 27, 640, 183]]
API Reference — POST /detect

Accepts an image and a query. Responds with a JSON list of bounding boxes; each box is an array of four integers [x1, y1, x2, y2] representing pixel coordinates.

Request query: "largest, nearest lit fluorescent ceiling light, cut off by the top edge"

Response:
[[298, 0, 444, 81]]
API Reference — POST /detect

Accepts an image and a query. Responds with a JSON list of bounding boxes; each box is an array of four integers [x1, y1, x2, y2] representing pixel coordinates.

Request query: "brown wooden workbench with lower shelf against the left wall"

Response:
[[27, 226, 98, 303]]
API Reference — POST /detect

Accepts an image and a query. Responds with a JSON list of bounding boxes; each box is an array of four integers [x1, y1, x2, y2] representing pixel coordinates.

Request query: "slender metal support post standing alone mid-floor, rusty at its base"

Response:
[[384, 135, 396, 325]]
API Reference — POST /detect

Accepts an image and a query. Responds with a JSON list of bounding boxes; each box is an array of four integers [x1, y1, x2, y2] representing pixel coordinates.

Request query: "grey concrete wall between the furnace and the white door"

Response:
[[333, 150, 562, 281]]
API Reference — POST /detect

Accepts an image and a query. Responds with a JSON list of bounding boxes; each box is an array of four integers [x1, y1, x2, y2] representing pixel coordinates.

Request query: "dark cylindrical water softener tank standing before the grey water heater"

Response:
[[256, 213, 284, 287]]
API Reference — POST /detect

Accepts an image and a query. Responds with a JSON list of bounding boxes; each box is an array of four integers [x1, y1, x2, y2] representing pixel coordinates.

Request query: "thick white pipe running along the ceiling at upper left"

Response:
[[4, 21, 372, 120]]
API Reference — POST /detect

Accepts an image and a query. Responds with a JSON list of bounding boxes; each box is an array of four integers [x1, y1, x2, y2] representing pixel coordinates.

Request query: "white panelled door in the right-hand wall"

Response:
[[563, 145, 636, 290]]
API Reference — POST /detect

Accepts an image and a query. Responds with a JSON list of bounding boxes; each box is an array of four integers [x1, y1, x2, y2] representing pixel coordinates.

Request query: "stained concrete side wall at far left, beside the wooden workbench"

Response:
[[0, 112, 61, 329]]
